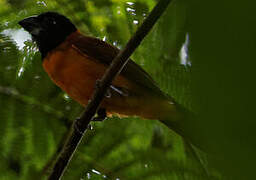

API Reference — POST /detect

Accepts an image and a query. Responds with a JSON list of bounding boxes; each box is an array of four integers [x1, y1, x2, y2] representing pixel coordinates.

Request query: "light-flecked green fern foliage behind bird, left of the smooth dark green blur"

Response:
[[0, 0, 219, 180]]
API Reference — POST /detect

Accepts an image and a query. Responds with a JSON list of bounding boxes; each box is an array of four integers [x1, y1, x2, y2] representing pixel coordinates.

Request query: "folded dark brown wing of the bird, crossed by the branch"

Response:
[[70, 33, 165, 96]]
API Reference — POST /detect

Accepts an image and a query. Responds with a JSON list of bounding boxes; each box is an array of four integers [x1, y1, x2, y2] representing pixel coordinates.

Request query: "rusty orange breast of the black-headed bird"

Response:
[[43, 41, 129, 106]]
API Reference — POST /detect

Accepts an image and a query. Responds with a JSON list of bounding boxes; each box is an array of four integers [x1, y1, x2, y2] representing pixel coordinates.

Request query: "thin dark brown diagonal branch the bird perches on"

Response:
[[48, 0, 171, 180]]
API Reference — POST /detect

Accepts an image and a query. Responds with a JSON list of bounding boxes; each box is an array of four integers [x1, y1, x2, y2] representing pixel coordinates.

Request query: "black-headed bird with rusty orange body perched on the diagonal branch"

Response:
[[18, 11, 194, 141]]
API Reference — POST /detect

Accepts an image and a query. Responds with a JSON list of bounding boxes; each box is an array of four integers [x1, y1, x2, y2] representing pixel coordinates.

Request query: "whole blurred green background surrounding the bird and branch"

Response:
[[0, 0, 256, 180]]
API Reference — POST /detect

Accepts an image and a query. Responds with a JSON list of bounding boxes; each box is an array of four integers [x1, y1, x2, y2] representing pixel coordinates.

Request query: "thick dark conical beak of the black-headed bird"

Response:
[[18, 16, 42, 36]]
